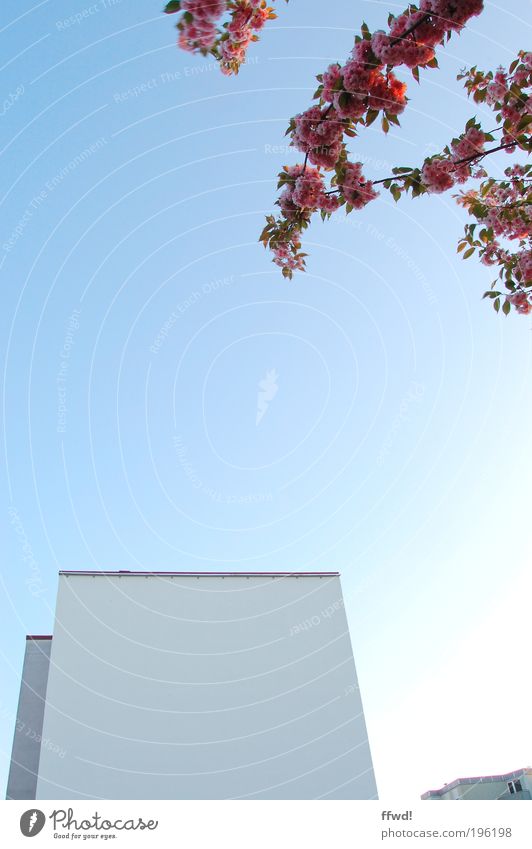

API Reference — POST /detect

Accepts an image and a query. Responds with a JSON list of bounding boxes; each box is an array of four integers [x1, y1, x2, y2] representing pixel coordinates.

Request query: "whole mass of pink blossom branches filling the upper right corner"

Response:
[[260, 0, 532, 313]]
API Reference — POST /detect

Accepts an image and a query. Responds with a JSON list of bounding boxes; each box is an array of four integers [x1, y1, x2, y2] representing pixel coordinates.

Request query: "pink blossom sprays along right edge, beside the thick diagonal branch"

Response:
[[384, 51, 532, 314]]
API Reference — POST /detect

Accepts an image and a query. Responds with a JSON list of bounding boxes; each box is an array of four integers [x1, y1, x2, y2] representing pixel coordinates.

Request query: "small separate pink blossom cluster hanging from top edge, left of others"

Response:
[[164, 0, 276, 75]]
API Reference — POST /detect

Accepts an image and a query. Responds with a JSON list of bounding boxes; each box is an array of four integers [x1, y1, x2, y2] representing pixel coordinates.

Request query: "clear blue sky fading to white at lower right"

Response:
[[0, 0, 532, 800]]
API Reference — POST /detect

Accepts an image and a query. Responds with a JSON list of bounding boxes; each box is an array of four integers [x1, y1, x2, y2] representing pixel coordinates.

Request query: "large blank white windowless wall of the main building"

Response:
[[37, 574, 376, 799]]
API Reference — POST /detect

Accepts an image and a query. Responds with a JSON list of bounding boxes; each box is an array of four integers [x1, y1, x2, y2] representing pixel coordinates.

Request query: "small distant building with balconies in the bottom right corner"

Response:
[[421, 768, 532, 800]]
